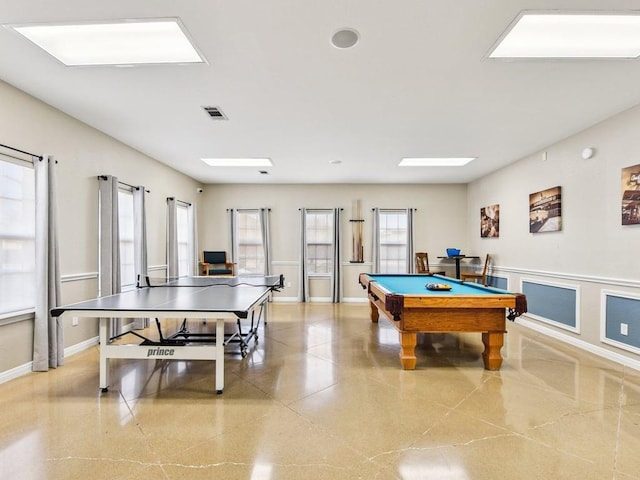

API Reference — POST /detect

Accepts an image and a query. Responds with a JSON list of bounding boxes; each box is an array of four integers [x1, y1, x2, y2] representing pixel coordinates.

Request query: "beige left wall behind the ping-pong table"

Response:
[[0, 82, 200, 375]]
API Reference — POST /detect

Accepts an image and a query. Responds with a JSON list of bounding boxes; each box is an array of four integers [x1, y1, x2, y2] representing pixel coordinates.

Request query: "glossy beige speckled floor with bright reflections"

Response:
[[0, 303, 640, 480]]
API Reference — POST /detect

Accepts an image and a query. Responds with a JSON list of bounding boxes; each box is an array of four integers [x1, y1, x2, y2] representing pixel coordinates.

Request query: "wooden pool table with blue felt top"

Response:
[[359, 273, 527, 370]]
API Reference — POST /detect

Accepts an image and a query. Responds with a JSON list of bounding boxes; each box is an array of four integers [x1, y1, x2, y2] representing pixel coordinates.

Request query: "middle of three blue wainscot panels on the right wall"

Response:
[[522, 281, 578, 328]]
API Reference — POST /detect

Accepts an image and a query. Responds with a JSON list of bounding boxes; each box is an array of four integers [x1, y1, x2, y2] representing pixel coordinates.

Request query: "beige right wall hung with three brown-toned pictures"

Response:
[[467, 103, 640, 361]]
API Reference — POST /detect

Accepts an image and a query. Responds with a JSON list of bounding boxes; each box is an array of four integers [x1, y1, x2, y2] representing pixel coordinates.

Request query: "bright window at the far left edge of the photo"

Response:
[[0, 159, 36, 315]]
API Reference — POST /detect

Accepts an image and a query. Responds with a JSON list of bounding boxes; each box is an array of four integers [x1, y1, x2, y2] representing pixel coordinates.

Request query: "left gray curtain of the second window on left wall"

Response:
[[98, 175, 122, 337]]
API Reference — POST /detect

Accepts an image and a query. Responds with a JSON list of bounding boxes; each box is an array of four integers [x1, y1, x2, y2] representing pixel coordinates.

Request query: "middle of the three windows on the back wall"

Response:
[[306, 210, 333, 275]]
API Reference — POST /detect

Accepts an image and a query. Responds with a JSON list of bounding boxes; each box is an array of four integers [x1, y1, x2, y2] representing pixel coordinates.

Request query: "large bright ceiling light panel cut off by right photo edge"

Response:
[[489, 13, 640, 58]]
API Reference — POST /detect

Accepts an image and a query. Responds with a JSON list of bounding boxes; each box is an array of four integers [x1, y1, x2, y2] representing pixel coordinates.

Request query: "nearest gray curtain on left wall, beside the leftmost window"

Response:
[[32, 156, 64, 372]]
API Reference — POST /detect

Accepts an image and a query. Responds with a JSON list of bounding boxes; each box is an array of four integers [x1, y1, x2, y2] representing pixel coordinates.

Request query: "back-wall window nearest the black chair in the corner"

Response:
[[236, 210, 265, 274]]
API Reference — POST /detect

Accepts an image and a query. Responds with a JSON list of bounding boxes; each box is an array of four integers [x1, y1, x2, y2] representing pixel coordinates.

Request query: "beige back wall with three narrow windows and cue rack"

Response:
[[199, 184, 469, 300]]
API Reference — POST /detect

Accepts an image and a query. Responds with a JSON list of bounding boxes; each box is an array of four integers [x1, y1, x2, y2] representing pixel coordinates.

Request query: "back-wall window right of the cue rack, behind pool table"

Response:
[[379, 210, 409, 273]]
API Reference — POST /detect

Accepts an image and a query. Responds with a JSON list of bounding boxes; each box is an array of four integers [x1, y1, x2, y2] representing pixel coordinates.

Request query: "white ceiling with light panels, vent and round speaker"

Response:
[[0, 0, 640, 184]]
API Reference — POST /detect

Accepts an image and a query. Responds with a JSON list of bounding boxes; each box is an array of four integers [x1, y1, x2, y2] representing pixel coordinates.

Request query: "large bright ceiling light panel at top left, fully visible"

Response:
[[12, 19, 204, 66]]
